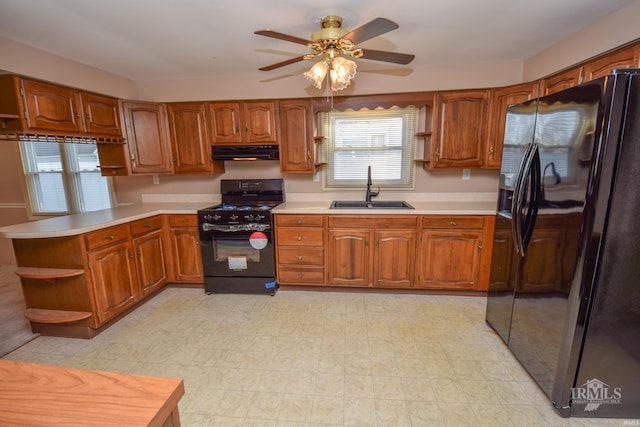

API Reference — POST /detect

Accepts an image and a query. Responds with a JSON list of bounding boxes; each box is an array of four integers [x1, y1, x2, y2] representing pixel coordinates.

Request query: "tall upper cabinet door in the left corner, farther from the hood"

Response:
[[122, 101, 172, 174]]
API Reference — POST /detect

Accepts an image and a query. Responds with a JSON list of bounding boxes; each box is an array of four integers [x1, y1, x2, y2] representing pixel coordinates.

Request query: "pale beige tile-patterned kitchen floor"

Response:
[[5, 288, 623, 427]]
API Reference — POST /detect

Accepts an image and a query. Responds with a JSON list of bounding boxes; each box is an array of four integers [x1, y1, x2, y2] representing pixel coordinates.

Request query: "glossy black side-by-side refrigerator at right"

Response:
[[486, 69, 640, 418]]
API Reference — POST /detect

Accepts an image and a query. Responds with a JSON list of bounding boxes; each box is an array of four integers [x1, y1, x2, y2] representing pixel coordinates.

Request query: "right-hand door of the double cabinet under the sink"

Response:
[[373, 230, 416, 288]]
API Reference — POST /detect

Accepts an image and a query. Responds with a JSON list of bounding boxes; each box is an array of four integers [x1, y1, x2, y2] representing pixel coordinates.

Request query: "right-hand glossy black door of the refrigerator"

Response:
[[509, 81, 603, 397]]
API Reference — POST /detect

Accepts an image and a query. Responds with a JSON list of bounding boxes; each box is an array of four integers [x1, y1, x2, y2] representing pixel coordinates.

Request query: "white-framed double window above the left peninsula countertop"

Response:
[[20, 140, 113, 214]]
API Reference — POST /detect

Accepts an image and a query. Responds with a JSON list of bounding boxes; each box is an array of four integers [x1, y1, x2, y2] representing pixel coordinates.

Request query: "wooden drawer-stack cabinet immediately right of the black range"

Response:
[[275, 215, 325, 286]]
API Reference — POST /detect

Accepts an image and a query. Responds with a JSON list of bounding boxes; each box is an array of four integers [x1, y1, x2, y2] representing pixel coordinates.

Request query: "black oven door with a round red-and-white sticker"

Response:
[[200, 224, 275, 277]]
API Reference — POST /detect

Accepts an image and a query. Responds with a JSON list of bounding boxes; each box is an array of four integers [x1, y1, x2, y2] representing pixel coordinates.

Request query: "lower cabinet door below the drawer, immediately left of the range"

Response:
[[170, 227, 204, 283]]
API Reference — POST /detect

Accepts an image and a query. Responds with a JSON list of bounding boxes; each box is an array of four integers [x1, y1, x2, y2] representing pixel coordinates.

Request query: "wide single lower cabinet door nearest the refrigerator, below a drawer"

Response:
[[419, 230, 482, 290]]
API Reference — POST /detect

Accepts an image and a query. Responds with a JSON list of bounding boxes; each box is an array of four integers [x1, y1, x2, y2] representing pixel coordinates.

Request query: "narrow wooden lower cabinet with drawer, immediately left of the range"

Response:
[[165, 214, 204, 283]]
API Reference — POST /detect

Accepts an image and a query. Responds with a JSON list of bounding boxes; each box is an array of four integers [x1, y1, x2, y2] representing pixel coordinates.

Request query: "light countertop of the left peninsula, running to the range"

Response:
[[0, 203, 211, 239]]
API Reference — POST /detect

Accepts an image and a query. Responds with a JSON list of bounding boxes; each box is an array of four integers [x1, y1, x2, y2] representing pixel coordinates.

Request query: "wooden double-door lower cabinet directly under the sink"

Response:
[[327, 215, 418, 288]]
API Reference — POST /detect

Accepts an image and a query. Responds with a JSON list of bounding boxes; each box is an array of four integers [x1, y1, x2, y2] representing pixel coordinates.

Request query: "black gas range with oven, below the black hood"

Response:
[[198, 179, 284, 295]]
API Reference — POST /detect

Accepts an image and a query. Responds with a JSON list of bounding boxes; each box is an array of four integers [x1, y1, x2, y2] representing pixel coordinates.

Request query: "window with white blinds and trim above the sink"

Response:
[[323, 107, 417, 188]]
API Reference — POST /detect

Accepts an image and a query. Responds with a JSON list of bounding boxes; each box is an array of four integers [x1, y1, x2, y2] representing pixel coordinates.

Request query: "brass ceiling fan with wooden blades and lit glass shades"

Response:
[[254, 15, 415, 90]]
